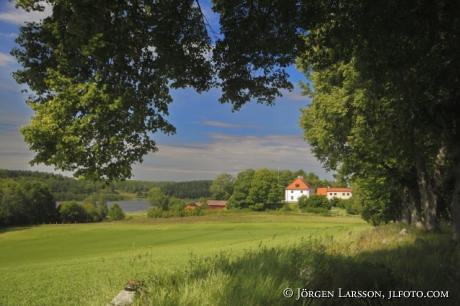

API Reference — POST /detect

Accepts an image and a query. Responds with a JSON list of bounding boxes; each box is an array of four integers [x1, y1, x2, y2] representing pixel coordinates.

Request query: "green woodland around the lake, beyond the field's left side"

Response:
[[0, 169, 212, 226]]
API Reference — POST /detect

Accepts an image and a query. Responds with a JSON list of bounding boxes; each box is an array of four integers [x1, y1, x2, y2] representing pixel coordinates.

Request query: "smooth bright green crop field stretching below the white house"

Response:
[[0, 214, 368, 305]]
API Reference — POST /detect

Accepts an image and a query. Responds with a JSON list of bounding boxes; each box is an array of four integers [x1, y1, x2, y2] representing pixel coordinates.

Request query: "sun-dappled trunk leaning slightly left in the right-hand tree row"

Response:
[[414, 129, 439, 232]]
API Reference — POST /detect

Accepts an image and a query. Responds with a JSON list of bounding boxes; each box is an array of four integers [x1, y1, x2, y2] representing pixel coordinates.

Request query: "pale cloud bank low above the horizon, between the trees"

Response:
[[133, 134, 332, 181]]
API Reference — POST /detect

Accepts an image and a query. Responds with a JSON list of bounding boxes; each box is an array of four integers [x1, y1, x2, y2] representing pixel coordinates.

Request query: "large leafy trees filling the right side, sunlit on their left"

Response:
[[298, 0, 460, 237]]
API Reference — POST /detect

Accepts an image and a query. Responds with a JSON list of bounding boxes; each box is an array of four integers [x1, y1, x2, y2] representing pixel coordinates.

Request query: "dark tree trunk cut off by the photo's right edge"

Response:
[[450, 143, 460, 242]]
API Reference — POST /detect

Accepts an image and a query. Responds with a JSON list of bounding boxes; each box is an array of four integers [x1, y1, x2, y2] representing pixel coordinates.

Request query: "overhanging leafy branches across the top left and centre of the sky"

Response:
[[12, 0, 310, 180]]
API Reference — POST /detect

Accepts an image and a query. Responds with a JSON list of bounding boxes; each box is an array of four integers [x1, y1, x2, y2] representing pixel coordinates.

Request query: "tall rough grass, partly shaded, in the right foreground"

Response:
[[142, 227, 460, 305]]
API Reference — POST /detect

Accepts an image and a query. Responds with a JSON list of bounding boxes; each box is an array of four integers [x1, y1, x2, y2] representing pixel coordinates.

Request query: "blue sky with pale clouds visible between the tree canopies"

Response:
[[0, 1, 332, 181]]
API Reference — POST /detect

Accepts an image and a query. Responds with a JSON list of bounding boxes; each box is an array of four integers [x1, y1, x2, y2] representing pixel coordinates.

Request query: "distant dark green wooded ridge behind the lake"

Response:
[[0, 169, 212, 201]]
